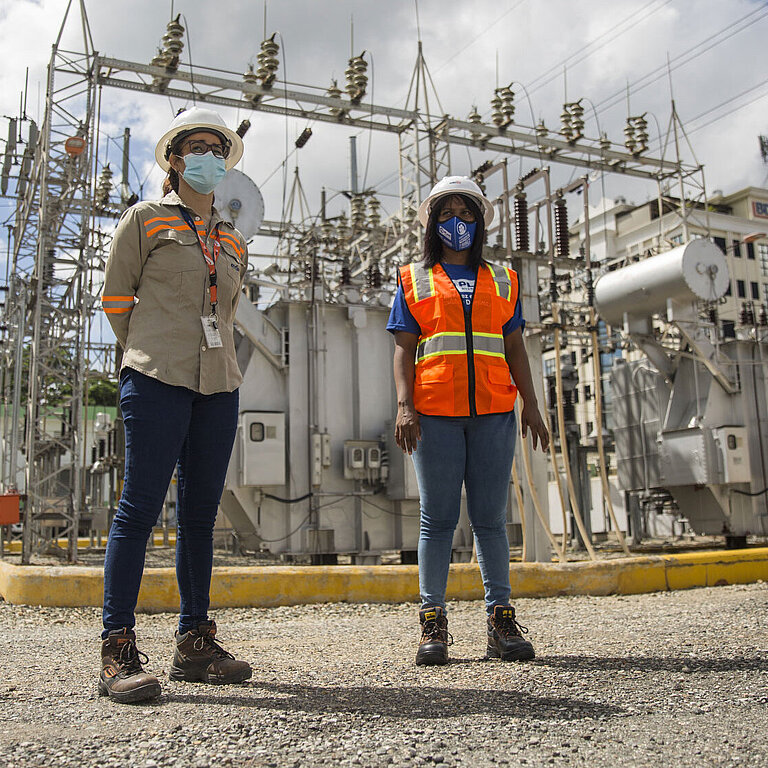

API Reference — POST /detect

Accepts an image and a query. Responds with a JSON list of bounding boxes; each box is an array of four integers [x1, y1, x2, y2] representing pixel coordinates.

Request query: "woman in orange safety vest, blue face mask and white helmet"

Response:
[[387, 176, 549, 665]]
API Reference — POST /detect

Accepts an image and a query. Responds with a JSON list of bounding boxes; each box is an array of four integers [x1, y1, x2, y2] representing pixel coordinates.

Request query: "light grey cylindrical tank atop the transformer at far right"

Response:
[[595, 240, 729, 325]]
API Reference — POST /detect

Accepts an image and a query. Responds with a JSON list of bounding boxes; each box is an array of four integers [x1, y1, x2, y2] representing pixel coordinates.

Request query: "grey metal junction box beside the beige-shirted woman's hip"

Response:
[[240, 411, 285, 486]]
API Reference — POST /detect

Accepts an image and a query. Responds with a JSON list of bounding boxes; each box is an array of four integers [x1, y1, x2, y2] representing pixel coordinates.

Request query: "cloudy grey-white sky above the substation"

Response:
[[0, 0, 768, 258]]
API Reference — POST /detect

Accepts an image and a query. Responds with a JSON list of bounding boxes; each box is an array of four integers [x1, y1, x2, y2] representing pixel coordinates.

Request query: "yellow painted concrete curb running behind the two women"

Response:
[[0, 548, 768, 612]]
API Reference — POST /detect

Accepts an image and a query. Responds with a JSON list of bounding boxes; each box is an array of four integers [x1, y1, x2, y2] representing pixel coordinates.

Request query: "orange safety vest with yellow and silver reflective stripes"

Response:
[[399, 262, 518, 416]]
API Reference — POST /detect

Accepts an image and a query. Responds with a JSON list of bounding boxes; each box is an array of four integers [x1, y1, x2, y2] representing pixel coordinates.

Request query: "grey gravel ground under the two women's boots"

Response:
[[0, 583, 768, 768]]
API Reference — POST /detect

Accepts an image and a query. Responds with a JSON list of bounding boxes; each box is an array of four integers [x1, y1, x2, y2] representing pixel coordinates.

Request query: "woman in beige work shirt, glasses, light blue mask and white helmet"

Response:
[[99, 107, 251, 702]]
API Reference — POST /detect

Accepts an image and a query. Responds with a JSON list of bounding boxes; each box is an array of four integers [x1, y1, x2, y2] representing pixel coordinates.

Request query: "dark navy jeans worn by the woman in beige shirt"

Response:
[[103, 368, 239, 637]]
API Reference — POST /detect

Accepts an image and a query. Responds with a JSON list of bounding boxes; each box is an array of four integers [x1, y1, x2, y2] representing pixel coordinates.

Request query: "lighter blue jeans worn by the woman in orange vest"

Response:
[[413, 411, 517, 613]]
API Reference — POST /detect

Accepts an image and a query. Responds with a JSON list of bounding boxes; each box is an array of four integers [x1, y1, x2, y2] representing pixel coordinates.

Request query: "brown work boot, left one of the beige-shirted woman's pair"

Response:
[[99, 629, 160, 704]]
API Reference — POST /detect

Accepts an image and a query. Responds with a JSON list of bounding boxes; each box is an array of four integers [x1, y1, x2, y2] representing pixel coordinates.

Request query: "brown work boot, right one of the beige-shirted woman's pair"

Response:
[[168, 621, 252, 685]]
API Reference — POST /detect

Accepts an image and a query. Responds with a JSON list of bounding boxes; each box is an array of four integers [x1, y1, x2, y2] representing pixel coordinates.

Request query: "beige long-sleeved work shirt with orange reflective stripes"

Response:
[[102, 192, 248, 395]]
